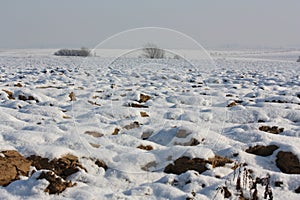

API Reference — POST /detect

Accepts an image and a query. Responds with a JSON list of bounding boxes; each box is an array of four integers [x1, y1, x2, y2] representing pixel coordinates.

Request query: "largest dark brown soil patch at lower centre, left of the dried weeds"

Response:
[[164, 156, 208, 174]]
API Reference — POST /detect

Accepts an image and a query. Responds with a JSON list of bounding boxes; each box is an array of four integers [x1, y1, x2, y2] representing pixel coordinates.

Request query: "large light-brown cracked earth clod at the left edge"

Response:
[[0, 150, 31, 186]]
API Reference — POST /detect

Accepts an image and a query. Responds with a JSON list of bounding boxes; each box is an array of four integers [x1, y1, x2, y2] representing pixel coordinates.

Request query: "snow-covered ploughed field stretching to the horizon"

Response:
[[0, 50, 300, 199]]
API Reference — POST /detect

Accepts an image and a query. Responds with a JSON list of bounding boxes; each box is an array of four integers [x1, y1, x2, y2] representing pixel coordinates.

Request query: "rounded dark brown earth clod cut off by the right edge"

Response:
[[276, 151, 300, 174]]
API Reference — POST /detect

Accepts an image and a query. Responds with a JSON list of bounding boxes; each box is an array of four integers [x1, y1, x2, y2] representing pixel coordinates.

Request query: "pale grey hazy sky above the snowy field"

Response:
[[0, 0, 300, 49]]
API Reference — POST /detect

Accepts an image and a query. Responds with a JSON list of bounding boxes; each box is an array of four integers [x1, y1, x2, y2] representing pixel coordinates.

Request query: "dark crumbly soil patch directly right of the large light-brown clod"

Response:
[[27, 154, 86, 179]]
